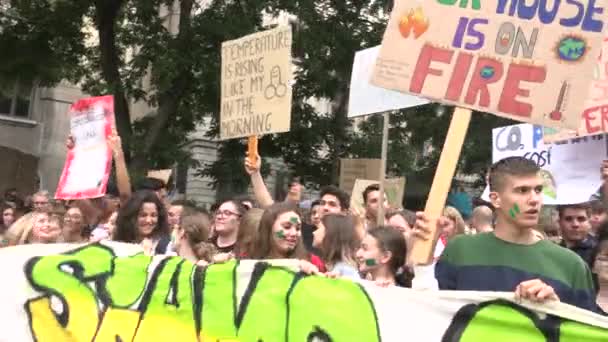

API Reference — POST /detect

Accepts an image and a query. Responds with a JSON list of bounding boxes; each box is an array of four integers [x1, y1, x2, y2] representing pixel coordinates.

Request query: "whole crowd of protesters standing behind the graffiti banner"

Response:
[[0, 151, 608, 313]]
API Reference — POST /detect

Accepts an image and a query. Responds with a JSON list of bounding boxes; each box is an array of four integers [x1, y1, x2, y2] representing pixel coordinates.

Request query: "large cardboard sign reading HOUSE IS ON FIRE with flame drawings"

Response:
[[372, 0, 608, 129]]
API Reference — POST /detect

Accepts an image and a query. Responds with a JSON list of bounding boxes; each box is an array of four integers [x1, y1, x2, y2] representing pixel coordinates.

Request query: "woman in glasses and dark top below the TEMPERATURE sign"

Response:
[[211, 200, 246, 253]]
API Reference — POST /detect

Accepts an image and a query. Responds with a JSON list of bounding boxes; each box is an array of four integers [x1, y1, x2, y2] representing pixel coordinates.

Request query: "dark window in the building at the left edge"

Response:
[[0, 80, 32, 118]]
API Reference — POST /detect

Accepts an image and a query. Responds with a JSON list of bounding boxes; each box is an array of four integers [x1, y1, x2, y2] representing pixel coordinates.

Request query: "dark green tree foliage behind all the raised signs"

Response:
[[0, 0, 509, 195]]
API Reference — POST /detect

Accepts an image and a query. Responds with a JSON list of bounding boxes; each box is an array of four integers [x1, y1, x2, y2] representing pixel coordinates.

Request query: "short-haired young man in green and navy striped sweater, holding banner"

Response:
[[414, 157, 597, 311]]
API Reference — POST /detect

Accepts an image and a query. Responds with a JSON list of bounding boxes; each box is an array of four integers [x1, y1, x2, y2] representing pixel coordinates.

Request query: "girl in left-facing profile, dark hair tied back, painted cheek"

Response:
[[356, 226, 407, 286]]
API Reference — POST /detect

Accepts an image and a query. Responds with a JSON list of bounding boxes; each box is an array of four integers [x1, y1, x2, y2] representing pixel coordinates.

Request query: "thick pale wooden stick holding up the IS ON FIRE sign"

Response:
[[409, 107, 471, 265]]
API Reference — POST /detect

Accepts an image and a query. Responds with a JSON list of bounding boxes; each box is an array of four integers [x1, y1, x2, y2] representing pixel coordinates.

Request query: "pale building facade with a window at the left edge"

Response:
[[0, 83, 84, 195]]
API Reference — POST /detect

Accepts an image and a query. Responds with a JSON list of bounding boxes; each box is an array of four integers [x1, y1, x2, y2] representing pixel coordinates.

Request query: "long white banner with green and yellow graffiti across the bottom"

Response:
[[0, 244, 608, 342]]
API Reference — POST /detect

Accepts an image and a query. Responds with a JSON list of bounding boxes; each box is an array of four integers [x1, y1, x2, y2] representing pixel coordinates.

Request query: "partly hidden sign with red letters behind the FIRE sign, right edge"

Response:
[[544, 38, 608, 143]]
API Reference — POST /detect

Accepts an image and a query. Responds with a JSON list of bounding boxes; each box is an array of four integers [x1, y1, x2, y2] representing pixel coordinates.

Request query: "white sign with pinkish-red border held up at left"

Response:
[[55, 96, 114, 200]]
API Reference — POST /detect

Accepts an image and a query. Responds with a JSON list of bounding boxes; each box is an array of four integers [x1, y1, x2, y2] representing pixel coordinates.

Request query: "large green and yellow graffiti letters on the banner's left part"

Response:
[[25, 244, 380, 342]]
